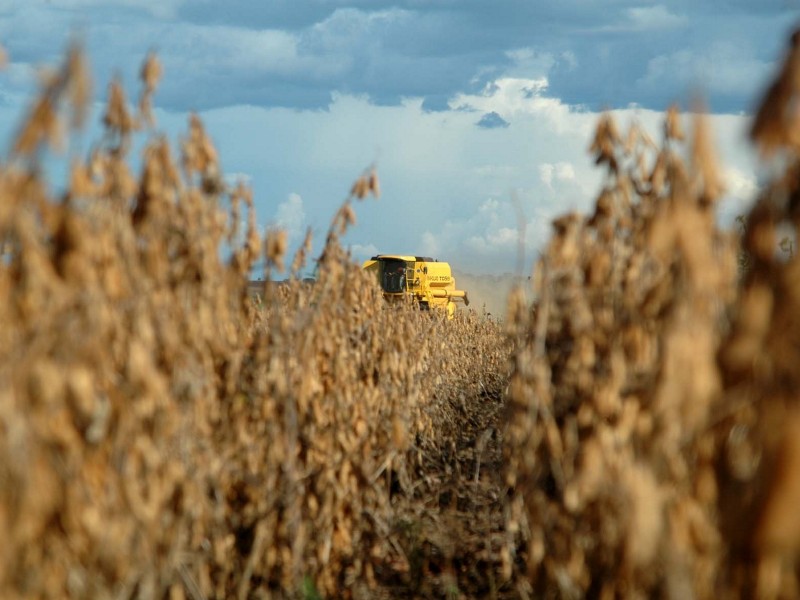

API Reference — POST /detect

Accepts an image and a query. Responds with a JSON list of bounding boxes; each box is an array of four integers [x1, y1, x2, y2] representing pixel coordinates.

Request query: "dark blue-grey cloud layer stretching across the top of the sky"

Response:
[[0, 0, 800, 112]]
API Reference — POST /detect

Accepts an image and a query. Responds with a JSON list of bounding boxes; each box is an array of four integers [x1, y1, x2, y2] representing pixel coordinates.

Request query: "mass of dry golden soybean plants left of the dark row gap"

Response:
[[0, 44, 505, 600]]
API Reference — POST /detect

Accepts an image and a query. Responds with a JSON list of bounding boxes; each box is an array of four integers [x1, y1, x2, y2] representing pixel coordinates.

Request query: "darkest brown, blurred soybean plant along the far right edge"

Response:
[[717, 32, 800, 598]]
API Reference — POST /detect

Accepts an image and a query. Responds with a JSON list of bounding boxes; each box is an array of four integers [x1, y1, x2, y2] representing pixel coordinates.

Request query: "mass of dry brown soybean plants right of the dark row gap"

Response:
[[505, 28, 800, 598]]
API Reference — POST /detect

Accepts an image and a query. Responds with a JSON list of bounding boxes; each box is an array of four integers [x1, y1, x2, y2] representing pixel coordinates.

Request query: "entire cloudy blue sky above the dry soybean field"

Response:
[[0, 0, 800, 275]]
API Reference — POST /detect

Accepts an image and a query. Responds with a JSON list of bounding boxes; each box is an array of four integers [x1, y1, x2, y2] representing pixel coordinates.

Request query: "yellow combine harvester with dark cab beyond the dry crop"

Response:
[[362, 254, 469, 319]]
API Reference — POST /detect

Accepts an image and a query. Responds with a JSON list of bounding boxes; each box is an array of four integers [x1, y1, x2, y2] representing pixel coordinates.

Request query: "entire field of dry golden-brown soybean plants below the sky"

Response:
[[7, 27, 800, 599]]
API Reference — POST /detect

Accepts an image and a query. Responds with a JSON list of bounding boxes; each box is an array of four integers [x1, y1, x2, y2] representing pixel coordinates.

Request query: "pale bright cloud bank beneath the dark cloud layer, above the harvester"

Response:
[[191, 75, 754, 273]]
